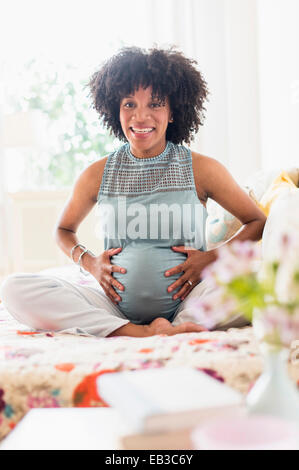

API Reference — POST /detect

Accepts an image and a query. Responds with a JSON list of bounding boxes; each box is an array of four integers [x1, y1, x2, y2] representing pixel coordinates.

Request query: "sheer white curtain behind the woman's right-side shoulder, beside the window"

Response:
[[150, 0, 261, 181]]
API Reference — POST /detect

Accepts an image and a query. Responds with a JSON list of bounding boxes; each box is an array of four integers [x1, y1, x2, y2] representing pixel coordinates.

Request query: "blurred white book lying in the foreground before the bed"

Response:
[[97, 368, 244, 432]]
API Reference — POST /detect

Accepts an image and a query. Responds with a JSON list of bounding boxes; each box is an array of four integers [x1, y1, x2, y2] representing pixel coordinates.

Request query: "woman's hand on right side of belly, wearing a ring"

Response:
[[164, 246, 216, 300]]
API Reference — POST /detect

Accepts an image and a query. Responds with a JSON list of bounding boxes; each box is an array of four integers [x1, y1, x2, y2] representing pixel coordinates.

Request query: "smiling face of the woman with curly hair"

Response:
[[119, 87, 171, 158]]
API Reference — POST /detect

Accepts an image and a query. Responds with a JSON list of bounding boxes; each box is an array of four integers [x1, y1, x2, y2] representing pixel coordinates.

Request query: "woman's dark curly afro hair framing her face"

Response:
[[88, 47, 209, 144]]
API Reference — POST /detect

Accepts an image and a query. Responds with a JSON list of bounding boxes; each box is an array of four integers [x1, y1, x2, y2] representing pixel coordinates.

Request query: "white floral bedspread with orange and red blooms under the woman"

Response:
[[0, 271, 299, 439]]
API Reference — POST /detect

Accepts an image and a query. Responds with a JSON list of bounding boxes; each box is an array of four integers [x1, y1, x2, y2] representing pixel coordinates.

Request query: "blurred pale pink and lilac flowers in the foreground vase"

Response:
[[188, 233, 299, 347]]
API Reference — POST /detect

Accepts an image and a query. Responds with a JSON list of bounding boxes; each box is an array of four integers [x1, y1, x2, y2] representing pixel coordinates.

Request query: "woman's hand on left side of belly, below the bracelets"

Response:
[[89, 247, 127, 305]]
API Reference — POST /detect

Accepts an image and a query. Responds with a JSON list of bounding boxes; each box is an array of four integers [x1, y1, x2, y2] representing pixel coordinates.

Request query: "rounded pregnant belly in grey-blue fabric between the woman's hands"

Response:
[[111, 244, 186, 324]]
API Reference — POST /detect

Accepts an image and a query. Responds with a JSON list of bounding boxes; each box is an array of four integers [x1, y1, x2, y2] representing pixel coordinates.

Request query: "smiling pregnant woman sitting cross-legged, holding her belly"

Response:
[[1, 48, 265, 337]]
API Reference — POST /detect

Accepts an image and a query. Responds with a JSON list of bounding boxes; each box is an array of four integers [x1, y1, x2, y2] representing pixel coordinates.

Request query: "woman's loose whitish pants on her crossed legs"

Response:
[[0, 273, 248, 337]]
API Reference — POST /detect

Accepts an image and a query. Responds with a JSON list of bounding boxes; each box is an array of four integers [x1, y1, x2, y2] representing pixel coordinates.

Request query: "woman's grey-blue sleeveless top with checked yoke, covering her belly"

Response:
[[96, 142, 206, 324]]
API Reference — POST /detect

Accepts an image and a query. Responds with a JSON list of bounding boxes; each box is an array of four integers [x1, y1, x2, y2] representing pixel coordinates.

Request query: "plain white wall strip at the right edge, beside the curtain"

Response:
[[258, 0, 299, 169]]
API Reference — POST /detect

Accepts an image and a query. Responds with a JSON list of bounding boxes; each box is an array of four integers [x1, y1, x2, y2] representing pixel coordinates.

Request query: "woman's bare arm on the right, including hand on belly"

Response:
[[165, 152, 266, 300]]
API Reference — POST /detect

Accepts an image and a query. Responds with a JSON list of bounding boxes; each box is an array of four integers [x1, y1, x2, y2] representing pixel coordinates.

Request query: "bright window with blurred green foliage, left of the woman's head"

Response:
[[0, 0, 155, 191]]
